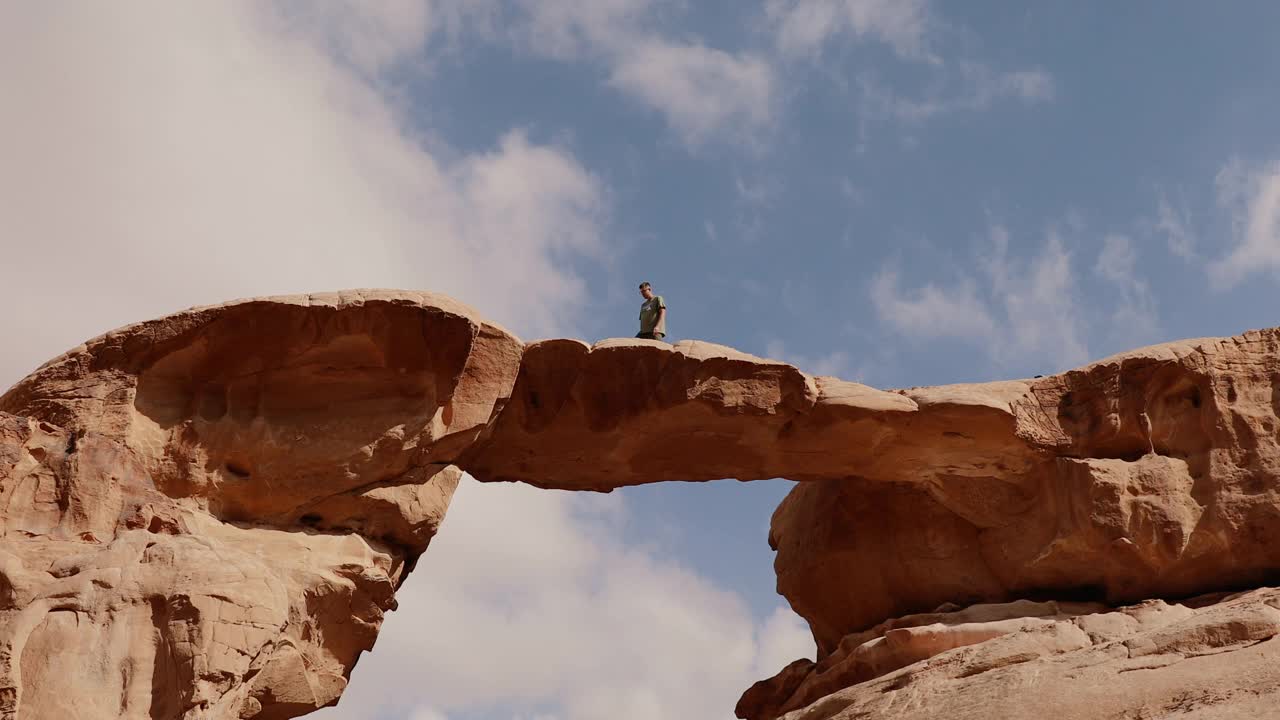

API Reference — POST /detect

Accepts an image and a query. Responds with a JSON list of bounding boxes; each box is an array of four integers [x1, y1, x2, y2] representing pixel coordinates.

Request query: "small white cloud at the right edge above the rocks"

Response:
[[1208, 158, 1280, 288]]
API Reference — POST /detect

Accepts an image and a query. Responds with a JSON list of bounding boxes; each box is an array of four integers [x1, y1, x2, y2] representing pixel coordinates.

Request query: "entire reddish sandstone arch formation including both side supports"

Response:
[[0, 291, 1280, 720]]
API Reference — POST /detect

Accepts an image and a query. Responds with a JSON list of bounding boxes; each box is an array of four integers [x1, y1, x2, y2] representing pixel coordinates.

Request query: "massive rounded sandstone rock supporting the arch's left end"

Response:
[[0, 292, 521, 720]]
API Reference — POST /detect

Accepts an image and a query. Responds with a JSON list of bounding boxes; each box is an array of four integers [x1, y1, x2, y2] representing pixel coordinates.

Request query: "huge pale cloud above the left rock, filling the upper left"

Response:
[[0, 3, 605, 384]]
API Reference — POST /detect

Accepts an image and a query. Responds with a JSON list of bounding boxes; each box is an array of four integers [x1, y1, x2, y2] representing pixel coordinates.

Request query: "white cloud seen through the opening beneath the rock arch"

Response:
[[316, 479, 814, 720]]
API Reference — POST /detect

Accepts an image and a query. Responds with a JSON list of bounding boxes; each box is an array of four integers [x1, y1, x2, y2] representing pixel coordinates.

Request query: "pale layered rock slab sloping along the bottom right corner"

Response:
[[737, 588, 1280, 720]]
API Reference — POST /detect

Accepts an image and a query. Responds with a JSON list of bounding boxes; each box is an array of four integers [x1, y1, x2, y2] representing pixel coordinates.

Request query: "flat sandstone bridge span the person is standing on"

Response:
[[462, 340, 1050, 491]]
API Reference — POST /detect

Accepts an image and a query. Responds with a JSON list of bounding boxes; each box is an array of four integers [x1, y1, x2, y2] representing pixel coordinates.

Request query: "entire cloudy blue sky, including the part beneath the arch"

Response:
[[0, 0, 1280, 720]]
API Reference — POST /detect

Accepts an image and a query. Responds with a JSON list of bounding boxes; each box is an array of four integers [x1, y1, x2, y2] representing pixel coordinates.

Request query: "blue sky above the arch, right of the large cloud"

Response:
[[389, 3, 1280, 386]]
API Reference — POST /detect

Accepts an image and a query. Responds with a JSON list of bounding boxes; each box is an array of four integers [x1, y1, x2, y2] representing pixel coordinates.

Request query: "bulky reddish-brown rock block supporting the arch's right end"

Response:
[[771, 331, 1280, 655]]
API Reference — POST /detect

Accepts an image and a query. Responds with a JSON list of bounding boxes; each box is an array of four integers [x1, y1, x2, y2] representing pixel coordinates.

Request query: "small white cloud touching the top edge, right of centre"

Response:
[[765, 0, 934, 58]]
